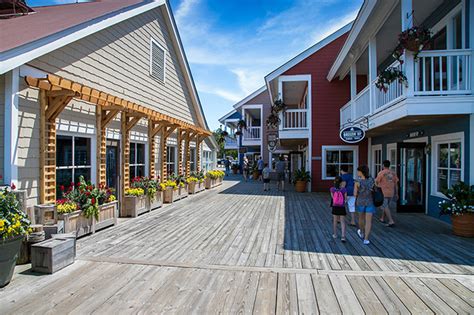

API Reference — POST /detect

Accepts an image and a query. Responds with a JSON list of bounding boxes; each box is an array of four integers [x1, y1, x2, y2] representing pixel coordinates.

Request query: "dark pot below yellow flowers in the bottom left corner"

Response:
[[0, 236, 24, 288]]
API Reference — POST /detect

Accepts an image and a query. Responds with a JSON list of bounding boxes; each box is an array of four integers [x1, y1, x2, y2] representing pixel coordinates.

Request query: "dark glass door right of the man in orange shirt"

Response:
[[397, 143, 426, 212]]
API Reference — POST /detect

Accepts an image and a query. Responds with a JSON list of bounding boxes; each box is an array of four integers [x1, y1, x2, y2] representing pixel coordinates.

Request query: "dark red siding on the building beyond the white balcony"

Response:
[[285, 35, 367, 191]]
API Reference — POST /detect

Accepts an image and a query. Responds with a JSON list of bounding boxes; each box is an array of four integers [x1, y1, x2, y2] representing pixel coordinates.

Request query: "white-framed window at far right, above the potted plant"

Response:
[[431, 132, 465, 197]]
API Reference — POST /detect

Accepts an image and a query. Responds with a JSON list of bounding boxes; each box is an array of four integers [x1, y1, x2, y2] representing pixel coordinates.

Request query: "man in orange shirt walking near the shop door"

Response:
[[375, 160, 398, 227]]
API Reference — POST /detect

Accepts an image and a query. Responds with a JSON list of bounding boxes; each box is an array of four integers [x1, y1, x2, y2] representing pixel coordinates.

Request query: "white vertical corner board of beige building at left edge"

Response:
[[3, 68, 20, 186]]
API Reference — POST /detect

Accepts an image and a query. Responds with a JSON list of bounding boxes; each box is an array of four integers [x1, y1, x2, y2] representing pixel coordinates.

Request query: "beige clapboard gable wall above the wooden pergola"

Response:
[[30, 8, 197, 123]]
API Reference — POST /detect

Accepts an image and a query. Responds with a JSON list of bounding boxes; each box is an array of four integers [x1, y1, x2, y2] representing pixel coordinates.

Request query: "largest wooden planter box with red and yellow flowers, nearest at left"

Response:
[[56, 176, 118, 237]]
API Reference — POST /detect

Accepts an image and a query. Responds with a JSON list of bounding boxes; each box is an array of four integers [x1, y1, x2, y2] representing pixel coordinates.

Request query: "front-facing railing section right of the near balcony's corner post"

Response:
[[414, 49, 472, 95]]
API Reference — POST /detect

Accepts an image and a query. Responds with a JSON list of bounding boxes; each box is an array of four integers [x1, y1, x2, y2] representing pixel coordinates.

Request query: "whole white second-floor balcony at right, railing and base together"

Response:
[[340, 49, 474, 129]]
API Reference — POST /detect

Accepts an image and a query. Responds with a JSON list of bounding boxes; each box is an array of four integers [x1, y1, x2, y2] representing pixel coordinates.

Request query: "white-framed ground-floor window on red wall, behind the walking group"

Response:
[[322, 146, 359, 180]]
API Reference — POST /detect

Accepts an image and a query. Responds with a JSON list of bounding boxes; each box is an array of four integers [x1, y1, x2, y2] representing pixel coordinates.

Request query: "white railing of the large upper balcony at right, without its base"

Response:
[[340, 49, 473, 124]]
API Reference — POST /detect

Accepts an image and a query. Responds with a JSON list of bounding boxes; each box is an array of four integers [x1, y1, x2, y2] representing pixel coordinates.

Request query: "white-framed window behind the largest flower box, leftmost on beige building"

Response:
[[56, 135, 92, 194]]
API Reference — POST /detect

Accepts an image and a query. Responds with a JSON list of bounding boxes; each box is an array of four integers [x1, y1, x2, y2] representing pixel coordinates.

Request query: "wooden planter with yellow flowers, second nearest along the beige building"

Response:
[[120, 177, 149, 217]]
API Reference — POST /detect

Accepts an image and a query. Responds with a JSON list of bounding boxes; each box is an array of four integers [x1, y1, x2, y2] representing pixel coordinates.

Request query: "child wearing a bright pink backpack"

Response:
[[329, 176, 347, 242]]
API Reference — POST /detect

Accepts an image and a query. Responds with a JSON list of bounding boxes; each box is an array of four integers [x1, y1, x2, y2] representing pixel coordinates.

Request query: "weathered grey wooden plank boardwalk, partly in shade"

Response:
[[0, 180, 474, 314]]
